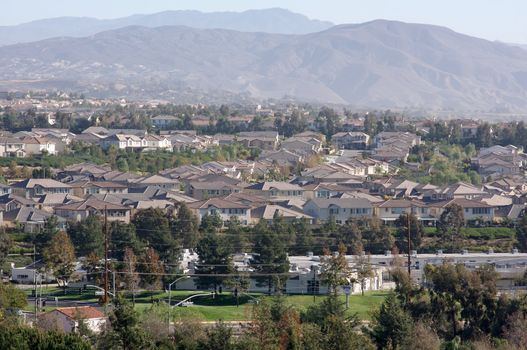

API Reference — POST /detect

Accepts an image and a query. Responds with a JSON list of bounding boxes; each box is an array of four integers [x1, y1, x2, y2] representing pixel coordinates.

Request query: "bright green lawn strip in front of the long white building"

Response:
[[26, 287, 387, 321]]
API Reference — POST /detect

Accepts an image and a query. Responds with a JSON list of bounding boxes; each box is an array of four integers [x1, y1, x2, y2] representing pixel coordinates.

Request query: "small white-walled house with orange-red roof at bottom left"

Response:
[[39, 306, 107, 334]]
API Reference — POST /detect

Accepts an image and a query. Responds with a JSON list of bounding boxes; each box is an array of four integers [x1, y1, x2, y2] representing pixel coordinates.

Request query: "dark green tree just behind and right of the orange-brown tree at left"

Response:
[[68, 215, 104, 256]]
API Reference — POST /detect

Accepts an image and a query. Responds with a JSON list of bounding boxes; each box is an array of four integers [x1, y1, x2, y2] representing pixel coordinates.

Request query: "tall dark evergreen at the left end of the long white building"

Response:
[[196, 233, 234, 290]]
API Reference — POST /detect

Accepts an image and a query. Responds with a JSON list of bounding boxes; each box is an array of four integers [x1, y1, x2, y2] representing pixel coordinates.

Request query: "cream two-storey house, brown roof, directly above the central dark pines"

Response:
[[187, 198, 251, 225]]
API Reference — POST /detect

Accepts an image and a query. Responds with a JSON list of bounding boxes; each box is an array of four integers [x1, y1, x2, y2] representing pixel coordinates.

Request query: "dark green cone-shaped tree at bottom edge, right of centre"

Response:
[[371, 293, 413, 349]]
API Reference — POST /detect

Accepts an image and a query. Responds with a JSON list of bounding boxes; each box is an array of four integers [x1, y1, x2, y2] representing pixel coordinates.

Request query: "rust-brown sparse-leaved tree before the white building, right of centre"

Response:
[[321, 243, 351, 295]]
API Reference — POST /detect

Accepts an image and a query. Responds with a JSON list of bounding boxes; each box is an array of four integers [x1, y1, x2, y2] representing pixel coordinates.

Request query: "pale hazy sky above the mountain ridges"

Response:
[[4, 0, 527, 44]]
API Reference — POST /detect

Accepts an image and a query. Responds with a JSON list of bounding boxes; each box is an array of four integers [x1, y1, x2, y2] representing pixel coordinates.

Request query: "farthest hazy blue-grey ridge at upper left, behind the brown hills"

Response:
[[0, 8, 333, 46]]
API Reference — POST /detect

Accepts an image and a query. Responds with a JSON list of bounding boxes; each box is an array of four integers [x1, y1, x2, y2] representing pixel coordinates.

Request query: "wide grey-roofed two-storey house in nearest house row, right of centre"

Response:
[[304, 198, 373, 224]]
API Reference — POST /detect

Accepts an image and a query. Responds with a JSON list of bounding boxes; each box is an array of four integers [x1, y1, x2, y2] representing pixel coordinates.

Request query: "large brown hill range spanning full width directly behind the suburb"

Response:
[[0, 20, 527, 111]]
